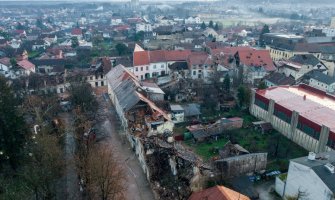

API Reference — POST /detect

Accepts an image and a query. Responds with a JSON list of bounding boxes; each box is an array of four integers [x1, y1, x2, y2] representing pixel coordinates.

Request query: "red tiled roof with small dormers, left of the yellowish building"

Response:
[[237, 49, 276, 72]]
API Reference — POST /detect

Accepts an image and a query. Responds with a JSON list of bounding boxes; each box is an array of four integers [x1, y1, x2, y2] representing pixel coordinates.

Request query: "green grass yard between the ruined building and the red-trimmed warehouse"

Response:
[[185, 109, 308, 171]]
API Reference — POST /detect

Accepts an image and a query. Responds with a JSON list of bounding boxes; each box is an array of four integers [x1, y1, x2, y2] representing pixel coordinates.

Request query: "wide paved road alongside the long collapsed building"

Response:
[[97, 95, 154, 200]]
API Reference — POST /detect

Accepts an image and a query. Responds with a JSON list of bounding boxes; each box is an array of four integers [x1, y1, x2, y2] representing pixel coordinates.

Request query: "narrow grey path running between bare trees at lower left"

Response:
[[58, 113, 81, 200]]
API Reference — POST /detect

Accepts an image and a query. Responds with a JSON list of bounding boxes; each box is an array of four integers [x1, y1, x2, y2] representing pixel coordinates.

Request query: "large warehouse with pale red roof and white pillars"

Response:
[[250, 84, 335, 153]]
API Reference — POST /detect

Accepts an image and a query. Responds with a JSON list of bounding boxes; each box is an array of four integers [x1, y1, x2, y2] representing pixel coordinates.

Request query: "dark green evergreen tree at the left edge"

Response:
[[0, 76, 27, 169]]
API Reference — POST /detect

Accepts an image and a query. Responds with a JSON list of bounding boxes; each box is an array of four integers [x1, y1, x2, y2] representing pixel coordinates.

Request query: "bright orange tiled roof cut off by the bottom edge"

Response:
[[189, 186, 250, 200]]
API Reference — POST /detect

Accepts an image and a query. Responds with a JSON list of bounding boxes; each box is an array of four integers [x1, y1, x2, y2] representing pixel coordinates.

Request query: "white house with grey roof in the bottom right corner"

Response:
[[276, 151, 335, 200]]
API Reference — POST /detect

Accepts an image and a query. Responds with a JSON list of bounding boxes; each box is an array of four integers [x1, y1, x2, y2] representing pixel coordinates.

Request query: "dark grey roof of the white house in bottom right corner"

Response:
[[291, 151, 335, 192]]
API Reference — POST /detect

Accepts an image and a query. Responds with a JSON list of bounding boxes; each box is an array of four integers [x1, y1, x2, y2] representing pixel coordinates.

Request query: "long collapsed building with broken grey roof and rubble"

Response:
[[107, 65, 210, 199]]
